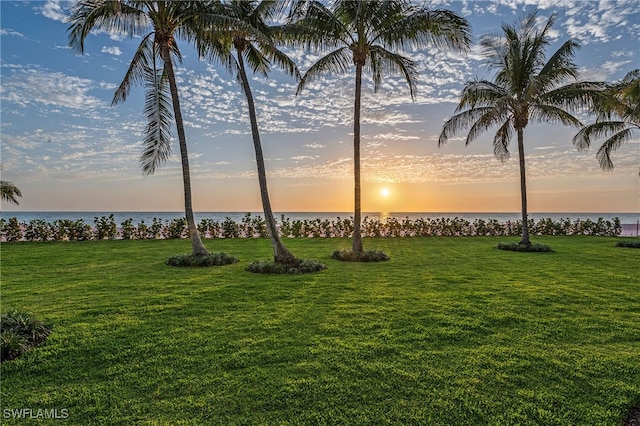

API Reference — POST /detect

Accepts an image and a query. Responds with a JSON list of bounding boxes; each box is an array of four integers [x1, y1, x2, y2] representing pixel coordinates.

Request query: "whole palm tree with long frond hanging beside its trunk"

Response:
[[69, 0, 208, 255]]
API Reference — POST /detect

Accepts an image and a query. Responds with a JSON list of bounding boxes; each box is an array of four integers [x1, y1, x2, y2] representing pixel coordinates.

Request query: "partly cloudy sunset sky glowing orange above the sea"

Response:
[[0, 0, 640, 213]]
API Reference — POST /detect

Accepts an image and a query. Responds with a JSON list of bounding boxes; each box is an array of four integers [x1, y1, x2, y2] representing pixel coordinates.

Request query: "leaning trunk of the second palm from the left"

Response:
[[236, 49, 296, 264]]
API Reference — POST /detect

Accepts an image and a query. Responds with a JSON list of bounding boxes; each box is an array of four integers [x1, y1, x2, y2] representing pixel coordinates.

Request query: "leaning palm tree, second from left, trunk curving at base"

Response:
[[201, 0, 299, 264]]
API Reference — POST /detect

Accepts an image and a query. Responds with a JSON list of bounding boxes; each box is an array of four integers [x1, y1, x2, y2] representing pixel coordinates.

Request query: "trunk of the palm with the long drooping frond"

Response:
[[161, 46, 208, 256]]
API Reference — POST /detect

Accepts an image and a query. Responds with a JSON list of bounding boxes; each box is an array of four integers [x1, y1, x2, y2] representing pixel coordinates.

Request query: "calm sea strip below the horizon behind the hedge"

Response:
[[0, 212, 640, 225]]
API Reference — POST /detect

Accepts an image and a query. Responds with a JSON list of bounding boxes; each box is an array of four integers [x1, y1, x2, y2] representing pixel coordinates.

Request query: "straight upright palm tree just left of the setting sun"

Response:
[[290, 0, 470, 253]]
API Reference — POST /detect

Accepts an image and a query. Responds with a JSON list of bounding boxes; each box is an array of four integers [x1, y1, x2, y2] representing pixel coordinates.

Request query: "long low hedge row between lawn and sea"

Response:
[[0, 213, 622, 241]]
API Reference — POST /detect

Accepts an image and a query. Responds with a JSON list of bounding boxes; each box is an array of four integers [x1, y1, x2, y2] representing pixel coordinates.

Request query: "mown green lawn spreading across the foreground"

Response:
[[0, 237, 640, 425]]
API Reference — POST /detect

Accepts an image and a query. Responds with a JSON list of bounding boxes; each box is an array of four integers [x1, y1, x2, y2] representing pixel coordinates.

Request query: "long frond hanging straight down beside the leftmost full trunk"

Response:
[[140, 68, 173, 175]]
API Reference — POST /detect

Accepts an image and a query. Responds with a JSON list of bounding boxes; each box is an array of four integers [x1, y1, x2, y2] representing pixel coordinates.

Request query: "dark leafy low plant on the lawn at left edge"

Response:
[[0, 309, 51, 362]]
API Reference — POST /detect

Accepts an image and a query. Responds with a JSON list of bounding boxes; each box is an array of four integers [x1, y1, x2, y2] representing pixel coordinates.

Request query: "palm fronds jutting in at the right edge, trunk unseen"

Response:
[[573, 69, 640, 170]]
